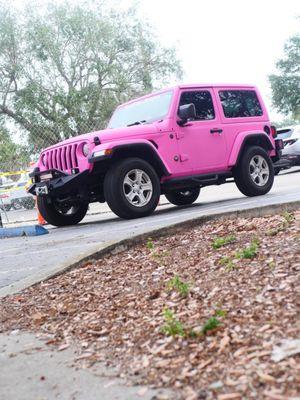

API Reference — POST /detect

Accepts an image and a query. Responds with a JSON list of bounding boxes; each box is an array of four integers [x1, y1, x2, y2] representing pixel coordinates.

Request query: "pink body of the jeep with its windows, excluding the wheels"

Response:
[[31, 84, 280, 223]]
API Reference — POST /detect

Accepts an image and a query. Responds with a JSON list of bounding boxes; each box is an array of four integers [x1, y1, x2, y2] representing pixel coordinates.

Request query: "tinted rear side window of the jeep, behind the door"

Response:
[[219, 90, 263, 118]]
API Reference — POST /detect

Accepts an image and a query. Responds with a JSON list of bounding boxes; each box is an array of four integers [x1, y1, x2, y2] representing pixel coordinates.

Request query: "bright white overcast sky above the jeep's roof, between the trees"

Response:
[[7, 0, 300, 121]]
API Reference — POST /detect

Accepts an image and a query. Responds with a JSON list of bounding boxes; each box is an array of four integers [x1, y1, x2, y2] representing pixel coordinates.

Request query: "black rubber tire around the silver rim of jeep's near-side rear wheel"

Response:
[[234, 146, 274, 197]]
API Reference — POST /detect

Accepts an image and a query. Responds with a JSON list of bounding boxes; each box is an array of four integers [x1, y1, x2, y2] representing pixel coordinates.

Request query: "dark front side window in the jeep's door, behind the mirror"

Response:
[[179, 90, 215, 120]]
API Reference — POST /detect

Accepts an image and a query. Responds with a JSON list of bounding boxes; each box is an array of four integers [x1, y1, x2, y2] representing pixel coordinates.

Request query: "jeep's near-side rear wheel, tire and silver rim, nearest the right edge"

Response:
[[234, 146, 274, 197]]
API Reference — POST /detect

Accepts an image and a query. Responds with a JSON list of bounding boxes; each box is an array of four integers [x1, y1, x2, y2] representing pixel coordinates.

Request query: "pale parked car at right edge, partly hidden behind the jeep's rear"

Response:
[[274, 125, 300, 175]]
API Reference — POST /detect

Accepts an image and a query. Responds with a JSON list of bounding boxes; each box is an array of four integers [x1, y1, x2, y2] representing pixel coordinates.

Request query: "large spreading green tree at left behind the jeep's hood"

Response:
[[0, 2, 181, 148]]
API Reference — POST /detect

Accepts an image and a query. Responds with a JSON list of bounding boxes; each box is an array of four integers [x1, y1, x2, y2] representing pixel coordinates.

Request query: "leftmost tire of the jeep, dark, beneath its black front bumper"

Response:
[[37, 196, 88, 226]]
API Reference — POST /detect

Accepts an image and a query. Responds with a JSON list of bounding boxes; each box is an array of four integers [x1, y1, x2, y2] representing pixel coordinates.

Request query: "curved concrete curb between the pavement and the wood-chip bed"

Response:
[[0, 200, 300, 298]]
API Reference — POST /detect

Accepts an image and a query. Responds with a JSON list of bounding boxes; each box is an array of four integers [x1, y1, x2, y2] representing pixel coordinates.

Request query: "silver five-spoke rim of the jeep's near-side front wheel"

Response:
[[123, 169, 153, 207]]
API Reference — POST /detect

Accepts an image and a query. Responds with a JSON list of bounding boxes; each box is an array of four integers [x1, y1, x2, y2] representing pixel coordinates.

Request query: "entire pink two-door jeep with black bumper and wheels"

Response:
[[29, 84, 282, 226]]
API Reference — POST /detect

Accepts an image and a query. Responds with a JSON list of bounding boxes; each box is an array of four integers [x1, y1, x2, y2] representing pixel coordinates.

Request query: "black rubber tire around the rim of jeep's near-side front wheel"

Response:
[[104, 158, 160, 219]]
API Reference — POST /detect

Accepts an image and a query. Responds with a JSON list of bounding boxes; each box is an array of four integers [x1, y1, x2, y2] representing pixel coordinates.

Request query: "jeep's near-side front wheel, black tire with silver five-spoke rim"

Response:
[[104, 158, 160, 219]]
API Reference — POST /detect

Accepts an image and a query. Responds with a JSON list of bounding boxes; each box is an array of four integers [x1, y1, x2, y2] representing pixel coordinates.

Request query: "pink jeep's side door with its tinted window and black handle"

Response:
[[176, 88, 227, 174]]
